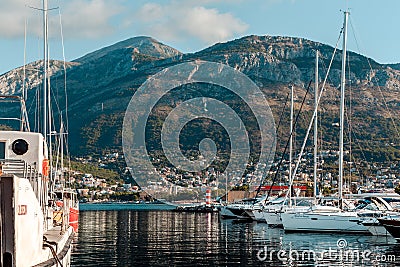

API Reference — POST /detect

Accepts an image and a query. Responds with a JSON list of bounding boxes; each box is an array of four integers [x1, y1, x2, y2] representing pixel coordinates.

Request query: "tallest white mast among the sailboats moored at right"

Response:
[[338, 11, 349, 208]]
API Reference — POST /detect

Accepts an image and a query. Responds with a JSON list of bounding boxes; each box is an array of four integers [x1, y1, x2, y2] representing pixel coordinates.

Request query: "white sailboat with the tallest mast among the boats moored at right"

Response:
[[281, 11, 368, 233]]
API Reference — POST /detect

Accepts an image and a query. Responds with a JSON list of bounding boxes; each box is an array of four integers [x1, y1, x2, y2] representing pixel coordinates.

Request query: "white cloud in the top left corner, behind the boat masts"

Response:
[[0, 0, 123, 38]]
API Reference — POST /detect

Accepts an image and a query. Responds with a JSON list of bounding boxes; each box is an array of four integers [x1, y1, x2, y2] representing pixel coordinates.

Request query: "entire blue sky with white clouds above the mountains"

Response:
[[0, 0, 400, 74]]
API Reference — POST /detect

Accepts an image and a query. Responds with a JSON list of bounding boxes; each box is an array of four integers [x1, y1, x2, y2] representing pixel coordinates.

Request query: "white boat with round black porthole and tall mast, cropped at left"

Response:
[[0, 0, 76, 267]]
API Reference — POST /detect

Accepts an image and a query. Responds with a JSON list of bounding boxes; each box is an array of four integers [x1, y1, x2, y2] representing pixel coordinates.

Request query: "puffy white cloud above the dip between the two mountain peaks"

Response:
[[131, 0, 248, 44]]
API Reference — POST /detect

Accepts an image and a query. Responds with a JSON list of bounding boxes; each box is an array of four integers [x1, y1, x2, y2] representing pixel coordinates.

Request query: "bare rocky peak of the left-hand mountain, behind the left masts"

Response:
[[0, 37, 182, 94]]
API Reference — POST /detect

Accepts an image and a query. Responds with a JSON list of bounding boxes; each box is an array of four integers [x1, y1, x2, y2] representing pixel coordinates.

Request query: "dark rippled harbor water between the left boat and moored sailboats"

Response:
[[71, 209, 400, 267]]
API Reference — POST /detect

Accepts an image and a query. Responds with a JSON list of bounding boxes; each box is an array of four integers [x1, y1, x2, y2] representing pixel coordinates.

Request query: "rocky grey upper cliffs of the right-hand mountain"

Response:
[[196, 36, 399, 85]]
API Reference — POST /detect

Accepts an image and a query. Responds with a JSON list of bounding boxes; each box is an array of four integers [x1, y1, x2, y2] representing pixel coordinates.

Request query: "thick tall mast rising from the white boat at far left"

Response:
[[42, 0, 48, 140]]
